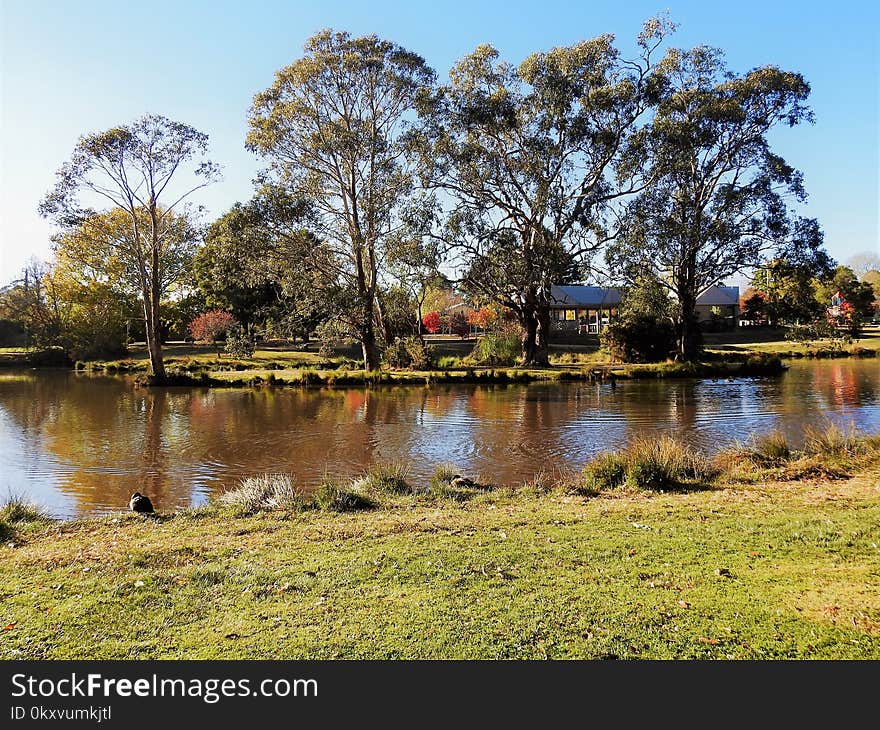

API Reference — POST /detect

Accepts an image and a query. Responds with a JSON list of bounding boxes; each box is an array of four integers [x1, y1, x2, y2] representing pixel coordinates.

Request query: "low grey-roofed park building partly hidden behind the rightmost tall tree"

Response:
[[550, 285, 739, 335]]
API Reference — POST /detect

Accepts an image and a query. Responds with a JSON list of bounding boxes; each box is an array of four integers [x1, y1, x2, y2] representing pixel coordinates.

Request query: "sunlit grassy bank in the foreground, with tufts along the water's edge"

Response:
[[0, 424, 880, 659]]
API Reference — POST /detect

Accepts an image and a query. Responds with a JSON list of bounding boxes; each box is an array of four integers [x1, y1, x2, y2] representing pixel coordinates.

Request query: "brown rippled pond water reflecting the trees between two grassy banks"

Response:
[[0, 360, 880, 517]]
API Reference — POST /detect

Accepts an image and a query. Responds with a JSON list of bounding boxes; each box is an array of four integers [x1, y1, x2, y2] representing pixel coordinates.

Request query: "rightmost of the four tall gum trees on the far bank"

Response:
[[606, 46, 828, 360]]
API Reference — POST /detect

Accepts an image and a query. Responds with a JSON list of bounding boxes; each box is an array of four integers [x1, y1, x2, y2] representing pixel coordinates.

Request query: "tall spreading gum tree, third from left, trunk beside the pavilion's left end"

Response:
[[410, 18, 672, 364]]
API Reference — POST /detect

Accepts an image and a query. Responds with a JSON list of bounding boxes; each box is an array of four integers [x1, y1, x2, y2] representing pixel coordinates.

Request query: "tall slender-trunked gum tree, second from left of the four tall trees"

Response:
[[247, 29, 435, 371]]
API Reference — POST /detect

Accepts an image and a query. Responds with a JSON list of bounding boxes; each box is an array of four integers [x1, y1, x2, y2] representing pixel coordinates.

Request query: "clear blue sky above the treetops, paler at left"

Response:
[[0, 0, 880, 286]]
